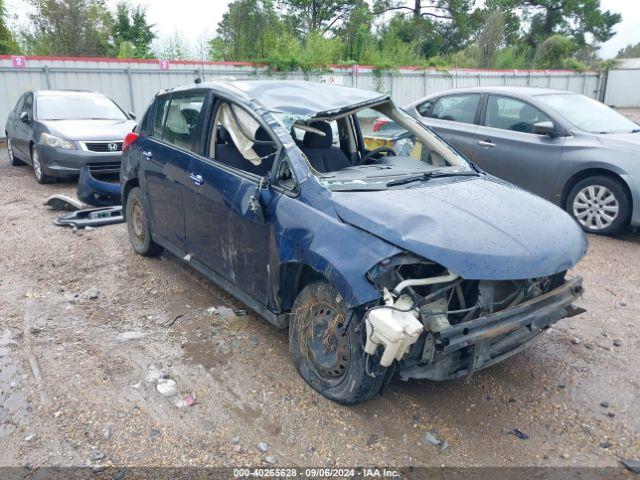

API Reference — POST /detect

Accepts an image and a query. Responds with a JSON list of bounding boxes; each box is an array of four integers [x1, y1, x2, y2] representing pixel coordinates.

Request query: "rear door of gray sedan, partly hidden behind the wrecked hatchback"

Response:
[[416, 92, 481, 159]]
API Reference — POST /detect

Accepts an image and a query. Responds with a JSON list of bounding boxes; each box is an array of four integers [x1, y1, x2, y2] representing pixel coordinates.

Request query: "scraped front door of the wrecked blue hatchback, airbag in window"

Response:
[[186, 103, 276, 305]]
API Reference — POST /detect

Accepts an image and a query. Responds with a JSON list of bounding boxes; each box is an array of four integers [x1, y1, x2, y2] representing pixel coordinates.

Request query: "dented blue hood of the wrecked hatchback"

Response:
[[332, 178, 587, 280]]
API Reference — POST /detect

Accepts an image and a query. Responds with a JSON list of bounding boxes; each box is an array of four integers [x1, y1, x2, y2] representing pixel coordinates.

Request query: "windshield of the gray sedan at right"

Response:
[[537, 93, 640, 133]]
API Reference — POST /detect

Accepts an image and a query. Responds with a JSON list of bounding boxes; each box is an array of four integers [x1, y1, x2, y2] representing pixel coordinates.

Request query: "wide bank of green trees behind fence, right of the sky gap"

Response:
[[209, 0, 620, 71]]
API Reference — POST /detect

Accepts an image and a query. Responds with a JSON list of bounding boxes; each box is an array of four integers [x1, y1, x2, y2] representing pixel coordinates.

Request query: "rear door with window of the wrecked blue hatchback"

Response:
[[140, 91, 207, 252]]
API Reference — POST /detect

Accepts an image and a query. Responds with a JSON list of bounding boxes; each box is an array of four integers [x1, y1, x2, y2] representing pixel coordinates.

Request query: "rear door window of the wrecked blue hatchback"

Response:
[[162, 92, 206, 151]]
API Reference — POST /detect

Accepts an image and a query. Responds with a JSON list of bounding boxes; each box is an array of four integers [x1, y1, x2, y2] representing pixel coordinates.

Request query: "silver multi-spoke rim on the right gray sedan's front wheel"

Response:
[[573, 185, 620, 231]]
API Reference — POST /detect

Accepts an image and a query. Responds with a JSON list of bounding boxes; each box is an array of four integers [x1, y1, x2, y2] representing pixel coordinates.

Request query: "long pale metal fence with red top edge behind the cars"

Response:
[[0, 56, 601, 137]]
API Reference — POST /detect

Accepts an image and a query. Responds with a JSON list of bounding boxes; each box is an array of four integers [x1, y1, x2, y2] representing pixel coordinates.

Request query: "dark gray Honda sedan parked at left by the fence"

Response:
[[5, 90, 136, 183]]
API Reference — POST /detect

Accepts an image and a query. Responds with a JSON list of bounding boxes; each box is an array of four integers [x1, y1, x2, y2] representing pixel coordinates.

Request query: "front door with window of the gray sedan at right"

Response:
[[473, 94, 565, 199]]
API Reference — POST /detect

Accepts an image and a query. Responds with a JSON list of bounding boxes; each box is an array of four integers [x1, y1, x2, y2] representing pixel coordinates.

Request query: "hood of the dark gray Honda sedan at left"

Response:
[[41, 120, 136, 140]]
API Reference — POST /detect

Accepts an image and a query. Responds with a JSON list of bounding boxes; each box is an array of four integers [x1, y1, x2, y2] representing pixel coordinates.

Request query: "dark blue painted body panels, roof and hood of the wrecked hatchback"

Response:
[[121, 81, 586, 313]]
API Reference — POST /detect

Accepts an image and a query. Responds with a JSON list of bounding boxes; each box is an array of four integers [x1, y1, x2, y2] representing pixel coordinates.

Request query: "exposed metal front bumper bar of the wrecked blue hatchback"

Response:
[[400, 277, 583, 380]]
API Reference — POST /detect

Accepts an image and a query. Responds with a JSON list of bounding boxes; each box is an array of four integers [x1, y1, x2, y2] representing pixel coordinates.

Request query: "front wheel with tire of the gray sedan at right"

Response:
[[565, 175, 631, 235]]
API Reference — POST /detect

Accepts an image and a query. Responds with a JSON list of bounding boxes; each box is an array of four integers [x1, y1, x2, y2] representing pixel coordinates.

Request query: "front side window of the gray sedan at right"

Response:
[[485, 95, 552, 133]]
